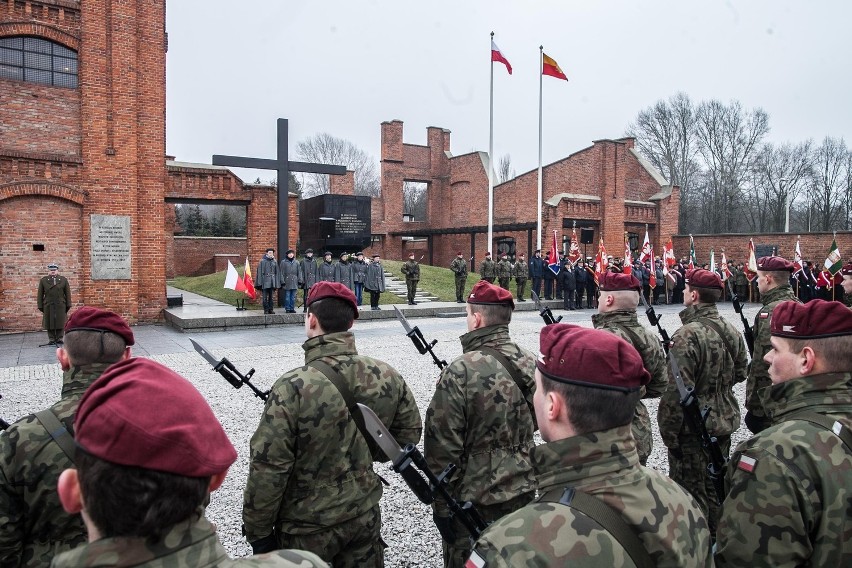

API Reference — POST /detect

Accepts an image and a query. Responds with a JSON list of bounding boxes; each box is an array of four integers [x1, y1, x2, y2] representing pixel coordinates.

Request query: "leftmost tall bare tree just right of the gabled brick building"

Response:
[[626, 93, 701, 232]]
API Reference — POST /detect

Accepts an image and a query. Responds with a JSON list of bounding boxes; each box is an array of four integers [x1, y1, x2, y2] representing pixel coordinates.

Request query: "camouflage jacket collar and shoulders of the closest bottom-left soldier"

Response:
[[50, 517, 328, 568]]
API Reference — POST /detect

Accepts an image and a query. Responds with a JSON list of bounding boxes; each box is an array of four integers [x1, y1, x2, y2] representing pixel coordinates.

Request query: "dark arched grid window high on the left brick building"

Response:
[[0, 36, 77, 89]]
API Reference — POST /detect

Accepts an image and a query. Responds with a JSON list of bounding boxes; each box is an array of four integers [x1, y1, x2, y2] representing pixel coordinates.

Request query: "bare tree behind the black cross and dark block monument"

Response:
[[296, 132, 381, 198]]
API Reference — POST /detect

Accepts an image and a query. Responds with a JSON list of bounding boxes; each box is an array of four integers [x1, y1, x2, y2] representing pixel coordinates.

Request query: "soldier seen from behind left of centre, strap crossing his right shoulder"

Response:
[[243, 282, 422, 568]]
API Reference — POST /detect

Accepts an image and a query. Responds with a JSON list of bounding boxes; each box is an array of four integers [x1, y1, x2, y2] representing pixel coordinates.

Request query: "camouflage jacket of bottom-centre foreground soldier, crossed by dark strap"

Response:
[[472, 425, 712, 568]]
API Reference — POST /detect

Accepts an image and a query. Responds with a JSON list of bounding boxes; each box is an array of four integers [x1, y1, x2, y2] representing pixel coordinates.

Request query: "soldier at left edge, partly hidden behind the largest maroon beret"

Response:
[[0, 306, 133, 566]]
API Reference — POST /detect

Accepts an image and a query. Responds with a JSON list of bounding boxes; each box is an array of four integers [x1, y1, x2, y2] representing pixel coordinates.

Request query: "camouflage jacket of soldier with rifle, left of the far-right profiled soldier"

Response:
[[657, 304, 748, 449]]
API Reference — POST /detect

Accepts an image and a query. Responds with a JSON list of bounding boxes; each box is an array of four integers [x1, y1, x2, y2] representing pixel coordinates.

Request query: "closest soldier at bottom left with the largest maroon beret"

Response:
[[51, 357, 326, 568]]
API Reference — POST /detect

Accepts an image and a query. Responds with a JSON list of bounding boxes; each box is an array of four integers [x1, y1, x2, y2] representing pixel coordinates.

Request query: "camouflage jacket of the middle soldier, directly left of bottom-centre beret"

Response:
[[423, 325, 535, 516]]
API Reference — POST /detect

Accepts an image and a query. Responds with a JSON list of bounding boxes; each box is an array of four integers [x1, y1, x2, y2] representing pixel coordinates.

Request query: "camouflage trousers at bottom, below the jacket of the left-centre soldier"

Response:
[[278, 505, 386, 568]]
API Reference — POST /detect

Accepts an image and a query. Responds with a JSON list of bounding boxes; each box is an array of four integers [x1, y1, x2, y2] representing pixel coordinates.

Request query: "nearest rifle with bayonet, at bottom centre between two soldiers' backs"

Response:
[[358, 402, 488, 540]]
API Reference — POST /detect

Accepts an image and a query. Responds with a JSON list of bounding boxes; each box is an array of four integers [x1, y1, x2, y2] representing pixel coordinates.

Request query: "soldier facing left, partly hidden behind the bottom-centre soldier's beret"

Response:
[[592, 272, 669, 465]]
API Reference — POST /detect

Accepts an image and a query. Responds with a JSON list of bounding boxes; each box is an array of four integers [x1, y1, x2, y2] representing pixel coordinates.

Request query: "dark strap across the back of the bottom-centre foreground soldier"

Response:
[[536, 487, 655, 568]]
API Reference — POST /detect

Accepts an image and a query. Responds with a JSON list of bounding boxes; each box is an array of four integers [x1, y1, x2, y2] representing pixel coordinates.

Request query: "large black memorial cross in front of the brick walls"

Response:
[[213, 118, 346, 258]]
